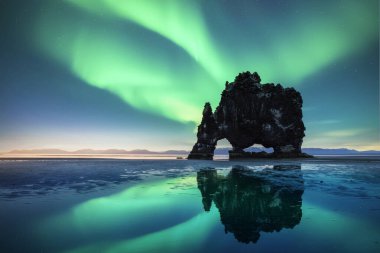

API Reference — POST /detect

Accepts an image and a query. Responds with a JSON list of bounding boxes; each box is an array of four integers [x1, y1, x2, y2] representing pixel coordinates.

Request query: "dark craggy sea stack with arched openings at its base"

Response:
[[188, 72, 309, 159]]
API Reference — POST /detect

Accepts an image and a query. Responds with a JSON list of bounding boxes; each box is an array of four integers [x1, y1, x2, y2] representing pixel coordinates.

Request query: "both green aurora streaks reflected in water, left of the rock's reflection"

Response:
[[39, 177, 218, 252]]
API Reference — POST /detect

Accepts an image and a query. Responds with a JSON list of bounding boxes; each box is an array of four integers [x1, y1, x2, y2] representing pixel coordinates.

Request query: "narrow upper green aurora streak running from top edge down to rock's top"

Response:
[[70, 0, 225, 82]]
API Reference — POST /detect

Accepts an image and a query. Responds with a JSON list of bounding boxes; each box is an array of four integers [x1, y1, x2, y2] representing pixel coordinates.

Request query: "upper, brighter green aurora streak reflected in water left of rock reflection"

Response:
[[39, 177, 202, 232]]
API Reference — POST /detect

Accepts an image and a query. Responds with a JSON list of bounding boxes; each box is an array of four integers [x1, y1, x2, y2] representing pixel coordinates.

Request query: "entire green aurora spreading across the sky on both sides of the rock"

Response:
[[35, 0, 378, 123]]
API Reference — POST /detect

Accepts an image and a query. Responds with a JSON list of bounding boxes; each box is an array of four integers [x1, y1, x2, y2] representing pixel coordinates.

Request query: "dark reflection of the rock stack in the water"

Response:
[[197, 165, 304, 243]]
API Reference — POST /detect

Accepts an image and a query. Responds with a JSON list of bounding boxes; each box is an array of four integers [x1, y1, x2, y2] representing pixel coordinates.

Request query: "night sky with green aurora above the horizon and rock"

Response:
[[0, 0, 380, 151]]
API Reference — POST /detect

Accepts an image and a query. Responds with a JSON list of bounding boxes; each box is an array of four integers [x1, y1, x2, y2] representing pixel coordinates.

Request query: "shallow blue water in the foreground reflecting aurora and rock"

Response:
[[0, 159, 380, 253]]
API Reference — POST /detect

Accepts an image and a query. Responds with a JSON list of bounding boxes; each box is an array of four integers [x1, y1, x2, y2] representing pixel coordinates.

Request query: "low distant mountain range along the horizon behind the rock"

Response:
[[3, 147, 380, 155]]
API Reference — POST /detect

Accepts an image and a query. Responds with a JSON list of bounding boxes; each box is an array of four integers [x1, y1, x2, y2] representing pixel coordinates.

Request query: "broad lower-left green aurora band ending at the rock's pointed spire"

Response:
[[38, 12, 219, 122]]
